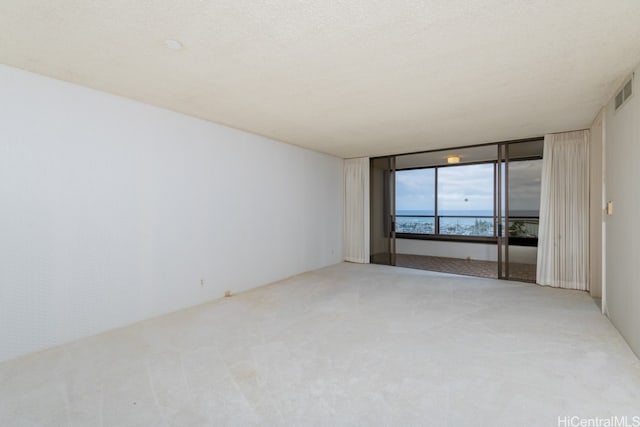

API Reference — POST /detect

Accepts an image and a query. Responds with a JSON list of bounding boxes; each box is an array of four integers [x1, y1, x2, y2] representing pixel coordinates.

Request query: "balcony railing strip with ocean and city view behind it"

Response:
[[395, 215, 539, 239]]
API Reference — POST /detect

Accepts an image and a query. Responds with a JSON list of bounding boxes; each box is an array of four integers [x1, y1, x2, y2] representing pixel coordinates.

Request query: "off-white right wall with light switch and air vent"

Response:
[[605, 68, 640, 355]]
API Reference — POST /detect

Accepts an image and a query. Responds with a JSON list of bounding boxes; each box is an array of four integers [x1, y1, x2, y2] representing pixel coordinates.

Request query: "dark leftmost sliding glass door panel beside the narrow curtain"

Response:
[[370, 156, 396, 265]]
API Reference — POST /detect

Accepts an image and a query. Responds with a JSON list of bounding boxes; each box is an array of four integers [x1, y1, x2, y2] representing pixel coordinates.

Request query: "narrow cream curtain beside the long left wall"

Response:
[[344, 157, 369, 264]]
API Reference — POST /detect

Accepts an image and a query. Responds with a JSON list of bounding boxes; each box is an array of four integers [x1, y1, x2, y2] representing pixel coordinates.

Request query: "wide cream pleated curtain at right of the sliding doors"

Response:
[[537, 130, 589, 291]]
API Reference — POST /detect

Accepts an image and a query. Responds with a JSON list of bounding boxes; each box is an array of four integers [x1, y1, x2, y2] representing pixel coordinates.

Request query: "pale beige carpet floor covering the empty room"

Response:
[[0, 263, 640, 427]]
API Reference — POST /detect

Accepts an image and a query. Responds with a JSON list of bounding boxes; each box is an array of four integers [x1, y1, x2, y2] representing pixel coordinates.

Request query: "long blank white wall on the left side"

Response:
[[0, 66, 343, 360]]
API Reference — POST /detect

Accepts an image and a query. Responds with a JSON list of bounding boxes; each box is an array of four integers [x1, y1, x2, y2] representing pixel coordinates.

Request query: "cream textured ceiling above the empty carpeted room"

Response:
[[0, 0, 640, 157]]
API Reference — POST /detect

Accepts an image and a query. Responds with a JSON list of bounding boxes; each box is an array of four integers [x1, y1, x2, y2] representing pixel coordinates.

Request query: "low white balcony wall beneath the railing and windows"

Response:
[[396, 239, 537, 264]]
